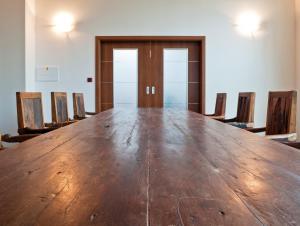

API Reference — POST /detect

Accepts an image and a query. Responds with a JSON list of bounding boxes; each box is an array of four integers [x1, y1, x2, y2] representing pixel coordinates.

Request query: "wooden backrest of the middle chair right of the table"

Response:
[[236, 92, 255, 123]]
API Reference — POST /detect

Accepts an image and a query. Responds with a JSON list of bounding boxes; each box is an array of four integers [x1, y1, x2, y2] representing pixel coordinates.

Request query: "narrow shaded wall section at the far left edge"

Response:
[[0, 0, 25, 134]]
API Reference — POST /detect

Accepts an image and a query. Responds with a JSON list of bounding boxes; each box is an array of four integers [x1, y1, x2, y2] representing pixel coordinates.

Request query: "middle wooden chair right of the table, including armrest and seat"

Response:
[[218, 92, 255, 128]]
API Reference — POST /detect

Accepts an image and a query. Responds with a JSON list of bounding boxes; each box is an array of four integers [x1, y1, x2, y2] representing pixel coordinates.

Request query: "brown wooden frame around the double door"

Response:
[[95, 36, 206, 114]]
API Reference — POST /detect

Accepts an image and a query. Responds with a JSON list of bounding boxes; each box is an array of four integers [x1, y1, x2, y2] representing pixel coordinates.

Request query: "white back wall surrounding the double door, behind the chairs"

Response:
[[36, 0, 295, 126]]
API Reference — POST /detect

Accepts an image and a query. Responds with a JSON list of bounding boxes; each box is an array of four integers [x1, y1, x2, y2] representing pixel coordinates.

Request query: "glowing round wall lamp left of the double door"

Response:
[[53, 12, 74, 33]]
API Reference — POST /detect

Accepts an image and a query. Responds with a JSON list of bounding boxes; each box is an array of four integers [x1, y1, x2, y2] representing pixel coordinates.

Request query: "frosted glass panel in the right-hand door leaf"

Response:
[[164, 49, 188, 109]]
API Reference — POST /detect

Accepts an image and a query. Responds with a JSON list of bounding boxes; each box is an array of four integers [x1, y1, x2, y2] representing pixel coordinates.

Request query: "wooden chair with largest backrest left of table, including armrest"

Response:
[[17, 92, 59, 135]]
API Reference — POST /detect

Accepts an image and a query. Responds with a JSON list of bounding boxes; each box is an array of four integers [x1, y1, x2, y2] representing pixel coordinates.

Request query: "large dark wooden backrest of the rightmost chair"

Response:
[[266, 91, 297, 135]]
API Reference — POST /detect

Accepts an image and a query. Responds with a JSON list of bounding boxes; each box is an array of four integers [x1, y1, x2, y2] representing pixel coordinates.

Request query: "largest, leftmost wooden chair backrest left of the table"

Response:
[[16, 92, 45, 129]]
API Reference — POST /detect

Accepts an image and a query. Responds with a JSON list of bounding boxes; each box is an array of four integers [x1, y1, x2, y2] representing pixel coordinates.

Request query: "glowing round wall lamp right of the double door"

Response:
[[237, 11, 261, 36]]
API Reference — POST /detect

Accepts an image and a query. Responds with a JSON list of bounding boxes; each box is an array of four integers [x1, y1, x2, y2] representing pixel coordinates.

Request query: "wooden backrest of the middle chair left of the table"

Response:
[[51, 92, 69, 123]]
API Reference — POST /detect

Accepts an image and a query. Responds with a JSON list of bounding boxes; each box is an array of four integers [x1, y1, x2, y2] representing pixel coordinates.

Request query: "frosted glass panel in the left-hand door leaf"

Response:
[[113, 49, 138, 108]]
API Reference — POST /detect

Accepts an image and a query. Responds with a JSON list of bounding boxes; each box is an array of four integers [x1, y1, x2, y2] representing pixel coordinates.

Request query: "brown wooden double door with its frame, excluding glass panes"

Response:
[[96, 37, 205, 113]]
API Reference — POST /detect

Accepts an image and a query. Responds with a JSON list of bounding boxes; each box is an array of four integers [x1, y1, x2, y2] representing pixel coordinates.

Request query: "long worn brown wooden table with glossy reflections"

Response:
[[0, 109, 300, 226]]
